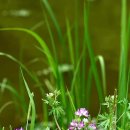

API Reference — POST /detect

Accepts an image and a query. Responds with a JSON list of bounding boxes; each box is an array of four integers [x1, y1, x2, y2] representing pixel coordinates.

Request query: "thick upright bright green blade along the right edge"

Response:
[[118, 0, 129, 129]]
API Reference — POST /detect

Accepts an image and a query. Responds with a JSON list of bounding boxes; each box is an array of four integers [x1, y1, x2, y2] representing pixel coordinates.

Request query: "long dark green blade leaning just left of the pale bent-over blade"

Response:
[[84, 2, 104, 103]]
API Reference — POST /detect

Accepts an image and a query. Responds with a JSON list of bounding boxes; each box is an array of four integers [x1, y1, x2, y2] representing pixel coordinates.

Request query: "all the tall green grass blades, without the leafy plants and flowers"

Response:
[[0, 0, 129, 130]]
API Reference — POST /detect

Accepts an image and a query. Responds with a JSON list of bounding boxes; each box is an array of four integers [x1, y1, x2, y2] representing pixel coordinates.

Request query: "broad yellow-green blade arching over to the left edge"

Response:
[[0, 28, 66, 106]]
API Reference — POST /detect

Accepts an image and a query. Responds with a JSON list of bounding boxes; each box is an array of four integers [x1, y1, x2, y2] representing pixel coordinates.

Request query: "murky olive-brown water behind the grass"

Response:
[[0, 0, 130, 126]]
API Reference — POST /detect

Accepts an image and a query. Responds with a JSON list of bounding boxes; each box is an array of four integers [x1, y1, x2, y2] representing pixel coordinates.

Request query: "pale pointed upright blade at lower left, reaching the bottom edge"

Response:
[[21, 69, 36, 130]]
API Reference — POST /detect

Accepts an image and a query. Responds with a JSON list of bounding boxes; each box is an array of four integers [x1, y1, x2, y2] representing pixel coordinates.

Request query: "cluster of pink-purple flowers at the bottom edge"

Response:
[[68, 108, 97, 130]]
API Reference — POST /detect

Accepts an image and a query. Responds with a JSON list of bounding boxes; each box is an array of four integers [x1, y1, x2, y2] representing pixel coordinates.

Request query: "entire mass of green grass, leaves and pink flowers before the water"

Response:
[[0, 0, 130, 130]]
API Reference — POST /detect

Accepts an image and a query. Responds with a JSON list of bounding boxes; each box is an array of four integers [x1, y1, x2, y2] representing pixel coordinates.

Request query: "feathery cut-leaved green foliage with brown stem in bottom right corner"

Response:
[[98, 95, 130, 130]]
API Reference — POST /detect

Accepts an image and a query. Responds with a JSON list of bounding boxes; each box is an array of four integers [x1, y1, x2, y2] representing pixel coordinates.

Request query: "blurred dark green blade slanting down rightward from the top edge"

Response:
[[42, 0, 64, 44]]
